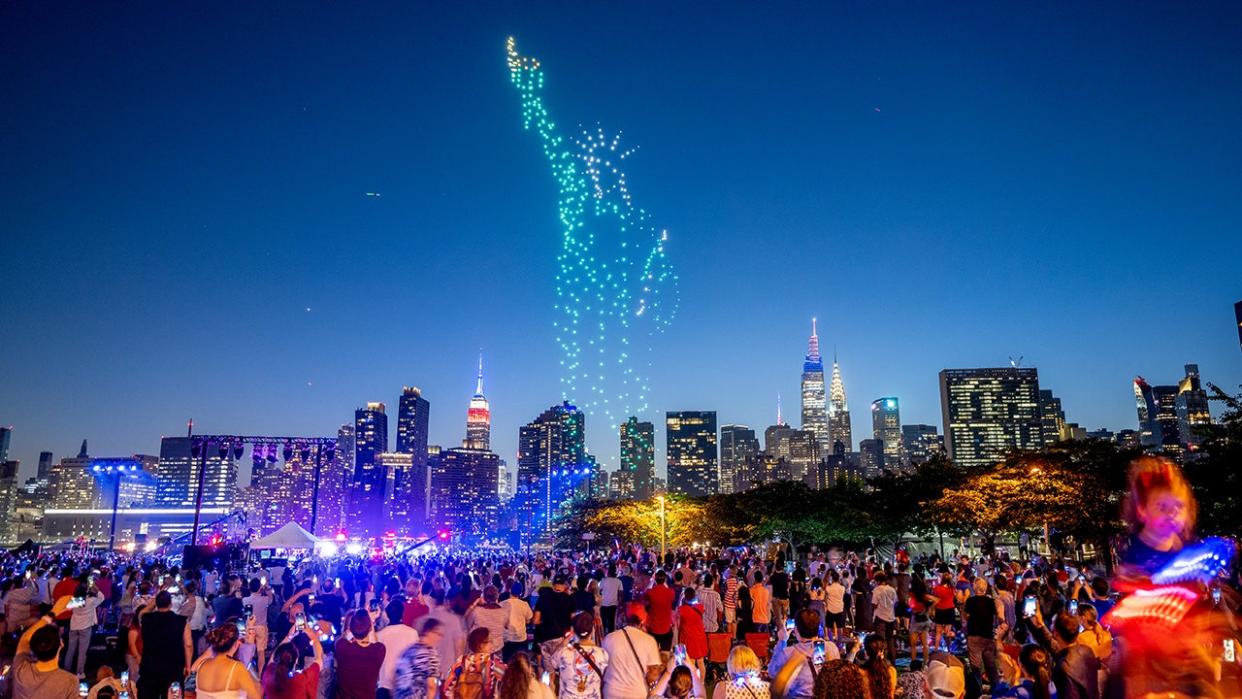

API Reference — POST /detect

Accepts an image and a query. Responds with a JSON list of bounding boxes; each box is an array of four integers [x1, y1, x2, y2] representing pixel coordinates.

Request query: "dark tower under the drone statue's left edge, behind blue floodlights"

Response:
[[514, 401, 594, 538]]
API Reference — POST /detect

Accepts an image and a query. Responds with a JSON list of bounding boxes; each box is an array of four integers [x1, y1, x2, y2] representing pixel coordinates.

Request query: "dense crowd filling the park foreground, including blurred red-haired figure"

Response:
[[0, 458, 1237, 699]]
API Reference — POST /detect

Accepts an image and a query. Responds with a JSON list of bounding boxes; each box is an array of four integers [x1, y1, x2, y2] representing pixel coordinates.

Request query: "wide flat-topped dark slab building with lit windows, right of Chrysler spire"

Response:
[[940, 366, 1043, 467]]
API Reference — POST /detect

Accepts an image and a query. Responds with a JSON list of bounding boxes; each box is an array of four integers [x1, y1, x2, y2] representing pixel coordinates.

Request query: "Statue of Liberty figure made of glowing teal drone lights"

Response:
[[507, 37, 677, 426]]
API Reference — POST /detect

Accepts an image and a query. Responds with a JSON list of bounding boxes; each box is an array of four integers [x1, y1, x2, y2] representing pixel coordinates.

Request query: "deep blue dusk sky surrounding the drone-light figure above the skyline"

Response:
[[0, 2, 1242, 481]]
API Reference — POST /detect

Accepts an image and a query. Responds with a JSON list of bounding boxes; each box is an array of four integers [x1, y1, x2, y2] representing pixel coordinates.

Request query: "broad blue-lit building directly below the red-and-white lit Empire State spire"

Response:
[[431, 448, 501, 539]]
